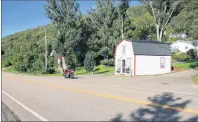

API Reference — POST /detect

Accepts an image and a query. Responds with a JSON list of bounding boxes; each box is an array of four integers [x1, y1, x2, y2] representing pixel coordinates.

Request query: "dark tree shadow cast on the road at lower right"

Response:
[[111, 93, 198, 122]]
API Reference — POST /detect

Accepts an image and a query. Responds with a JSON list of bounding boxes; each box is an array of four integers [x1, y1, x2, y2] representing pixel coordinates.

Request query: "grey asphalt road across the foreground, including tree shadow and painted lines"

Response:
[[2, 70, 198, 121]]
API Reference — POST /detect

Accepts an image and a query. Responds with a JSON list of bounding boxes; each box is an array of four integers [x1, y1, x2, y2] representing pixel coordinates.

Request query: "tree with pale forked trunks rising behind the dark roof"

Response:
[[141, 0, 183, 41]]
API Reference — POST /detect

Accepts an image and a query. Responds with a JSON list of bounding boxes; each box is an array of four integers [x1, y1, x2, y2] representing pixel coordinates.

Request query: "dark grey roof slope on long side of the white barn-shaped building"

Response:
[[128, 40, 171, 56]]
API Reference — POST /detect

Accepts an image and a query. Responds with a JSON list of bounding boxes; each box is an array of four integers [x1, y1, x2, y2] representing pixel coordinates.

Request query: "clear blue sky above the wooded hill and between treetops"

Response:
[[1, 0, 140, 38]]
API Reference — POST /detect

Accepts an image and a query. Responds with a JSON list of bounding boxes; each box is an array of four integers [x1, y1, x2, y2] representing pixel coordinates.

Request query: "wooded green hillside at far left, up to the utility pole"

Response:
[[1, 25, 54, 73]]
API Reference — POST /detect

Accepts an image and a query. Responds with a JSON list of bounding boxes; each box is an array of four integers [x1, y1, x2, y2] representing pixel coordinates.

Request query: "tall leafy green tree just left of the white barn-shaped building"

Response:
[[89, 0, 119, 59]]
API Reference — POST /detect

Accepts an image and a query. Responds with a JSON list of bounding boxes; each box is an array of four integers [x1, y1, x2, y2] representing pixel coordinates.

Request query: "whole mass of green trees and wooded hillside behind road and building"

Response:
[[1, 0, 198, 73]]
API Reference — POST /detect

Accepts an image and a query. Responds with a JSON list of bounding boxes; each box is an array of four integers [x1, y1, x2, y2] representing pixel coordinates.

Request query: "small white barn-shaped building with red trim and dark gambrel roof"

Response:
[[115, 39, 172, 76]]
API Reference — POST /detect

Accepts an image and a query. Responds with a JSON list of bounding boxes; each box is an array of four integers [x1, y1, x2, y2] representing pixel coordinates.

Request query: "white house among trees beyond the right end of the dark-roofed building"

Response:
[[170, 40, 195, 53]]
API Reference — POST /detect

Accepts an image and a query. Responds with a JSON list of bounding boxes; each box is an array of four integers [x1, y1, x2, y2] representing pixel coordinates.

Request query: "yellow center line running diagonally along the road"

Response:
[[2, 73, 198, 114]]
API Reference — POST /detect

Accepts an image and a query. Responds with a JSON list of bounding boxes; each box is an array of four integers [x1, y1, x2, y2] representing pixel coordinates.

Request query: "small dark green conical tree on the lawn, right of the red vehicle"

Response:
[[84, 51, 96, 74]]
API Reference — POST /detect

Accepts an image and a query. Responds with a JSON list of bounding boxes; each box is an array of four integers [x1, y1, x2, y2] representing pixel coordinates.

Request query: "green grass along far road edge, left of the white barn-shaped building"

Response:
[[4, 65, 114, 76]]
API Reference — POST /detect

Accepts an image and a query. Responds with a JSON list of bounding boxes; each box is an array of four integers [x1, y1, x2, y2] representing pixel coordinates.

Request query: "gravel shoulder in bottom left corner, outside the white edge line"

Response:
[[1, 102, 20, 122]]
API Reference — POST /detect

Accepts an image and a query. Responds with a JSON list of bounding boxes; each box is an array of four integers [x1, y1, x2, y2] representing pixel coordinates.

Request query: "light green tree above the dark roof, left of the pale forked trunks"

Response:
[[125, 6, 155, 40]]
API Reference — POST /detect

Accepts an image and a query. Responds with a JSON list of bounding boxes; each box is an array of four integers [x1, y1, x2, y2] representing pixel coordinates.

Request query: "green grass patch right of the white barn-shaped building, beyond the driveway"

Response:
[[173, 59, 198, 70]]
